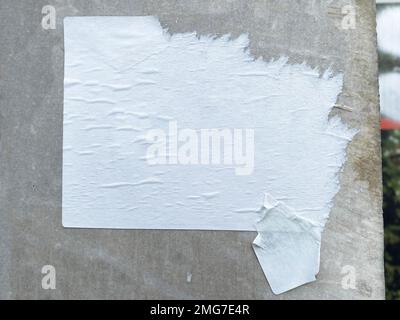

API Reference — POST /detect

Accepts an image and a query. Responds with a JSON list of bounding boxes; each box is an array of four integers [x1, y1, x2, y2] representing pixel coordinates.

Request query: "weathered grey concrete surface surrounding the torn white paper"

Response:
[[0, 0, 384, 299]]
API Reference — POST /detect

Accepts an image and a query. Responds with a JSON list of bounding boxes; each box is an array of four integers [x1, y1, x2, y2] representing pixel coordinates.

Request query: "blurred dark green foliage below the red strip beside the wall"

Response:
[[382, 130, 400, 300]]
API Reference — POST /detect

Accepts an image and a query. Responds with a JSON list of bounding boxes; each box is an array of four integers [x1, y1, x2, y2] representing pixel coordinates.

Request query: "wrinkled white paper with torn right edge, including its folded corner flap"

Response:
[[62, 17, 354, 293]]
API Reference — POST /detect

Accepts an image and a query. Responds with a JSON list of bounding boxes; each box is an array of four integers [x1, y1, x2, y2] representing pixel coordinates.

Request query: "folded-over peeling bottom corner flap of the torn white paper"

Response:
[[253, 194, 323, 294]]
